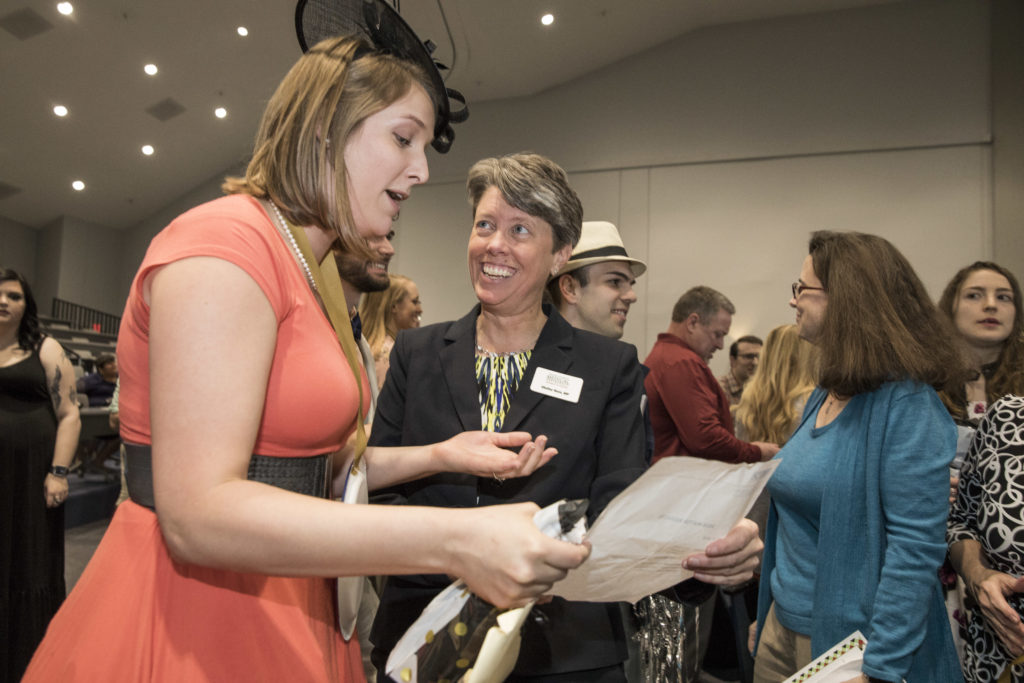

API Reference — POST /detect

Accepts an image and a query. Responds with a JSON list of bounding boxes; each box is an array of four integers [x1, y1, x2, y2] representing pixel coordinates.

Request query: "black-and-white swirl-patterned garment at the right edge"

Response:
[[946, 396, 1024, 683]]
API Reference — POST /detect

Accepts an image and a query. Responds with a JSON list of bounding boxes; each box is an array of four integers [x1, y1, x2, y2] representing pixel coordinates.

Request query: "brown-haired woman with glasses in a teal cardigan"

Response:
[[755, 231, 963, 683]]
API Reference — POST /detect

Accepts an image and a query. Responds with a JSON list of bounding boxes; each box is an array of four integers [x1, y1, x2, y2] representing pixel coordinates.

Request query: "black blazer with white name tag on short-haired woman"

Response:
[[370, 306, 645, 680]]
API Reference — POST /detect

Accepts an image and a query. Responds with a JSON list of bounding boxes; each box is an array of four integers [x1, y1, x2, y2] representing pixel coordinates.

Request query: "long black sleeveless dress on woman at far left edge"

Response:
[[0, 348, 65, 681]]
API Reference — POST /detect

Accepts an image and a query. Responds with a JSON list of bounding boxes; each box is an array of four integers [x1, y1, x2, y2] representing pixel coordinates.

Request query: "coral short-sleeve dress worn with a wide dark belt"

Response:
[[25, 196, 364, 683]]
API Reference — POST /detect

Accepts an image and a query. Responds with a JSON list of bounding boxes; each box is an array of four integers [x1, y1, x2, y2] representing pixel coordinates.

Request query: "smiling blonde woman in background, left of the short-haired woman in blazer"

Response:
[[359, 275, 423, 388]]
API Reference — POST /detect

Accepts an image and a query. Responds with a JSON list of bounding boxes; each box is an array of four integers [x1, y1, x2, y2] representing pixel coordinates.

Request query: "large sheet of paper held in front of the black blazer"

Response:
[[551, 457, 780, 602]]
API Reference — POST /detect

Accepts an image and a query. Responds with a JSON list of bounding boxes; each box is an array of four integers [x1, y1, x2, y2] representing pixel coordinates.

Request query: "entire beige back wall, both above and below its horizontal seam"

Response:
[[385, 1, 991, 372]]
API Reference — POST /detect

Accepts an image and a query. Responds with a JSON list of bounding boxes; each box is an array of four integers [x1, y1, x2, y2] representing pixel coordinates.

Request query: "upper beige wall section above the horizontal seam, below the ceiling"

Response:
[[419, 0, 990, 181]]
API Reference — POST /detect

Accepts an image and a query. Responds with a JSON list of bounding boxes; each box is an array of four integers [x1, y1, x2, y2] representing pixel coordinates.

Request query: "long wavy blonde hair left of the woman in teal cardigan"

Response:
[[736, 325, 818, 445]]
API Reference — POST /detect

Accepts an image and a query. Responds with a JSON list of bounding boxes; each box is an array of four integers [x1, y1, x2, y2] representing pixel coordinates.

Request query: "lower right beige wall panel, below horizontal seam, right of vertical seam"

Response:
[[645, 146, 990, 372]]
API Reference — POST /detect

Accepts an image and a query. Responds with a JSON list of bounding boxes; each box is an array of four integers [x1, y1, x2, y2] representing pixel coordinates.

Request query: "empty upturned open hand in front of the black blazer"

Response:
[[438, 431, 558, 481]]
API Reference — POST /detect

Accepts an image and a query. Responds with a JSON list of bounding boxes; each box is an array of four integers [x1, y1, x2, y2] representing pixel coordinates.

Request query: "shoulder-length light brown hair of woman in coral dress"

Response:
[[222, 37, 433, 259]]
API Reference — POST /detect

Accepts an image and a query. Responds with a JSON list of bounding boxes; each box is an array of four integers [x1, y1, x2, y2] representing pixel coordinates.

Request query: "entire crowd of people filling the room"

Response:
[[0, 9, 1024, 683]]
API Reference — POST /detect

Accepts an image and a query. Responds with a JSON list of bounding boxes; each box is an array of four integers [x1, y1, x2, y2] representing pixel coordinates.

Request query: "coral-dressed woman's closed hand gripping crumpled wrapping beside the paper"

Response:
[[450, 503, 590, 609]]
